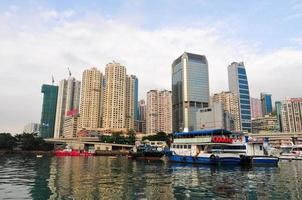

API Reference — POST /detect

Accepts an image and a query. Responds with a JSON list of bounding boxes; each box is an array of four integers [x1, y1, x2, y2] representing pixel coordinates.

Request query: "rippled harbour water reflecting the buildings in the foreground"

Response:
[[0, 155, 302, 200]]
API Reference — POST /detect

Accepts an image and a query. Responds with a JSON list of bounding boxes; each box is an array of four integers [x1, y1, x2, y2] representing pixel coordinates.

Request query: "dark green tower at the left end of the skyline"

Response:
[[40, 84, 58, 138]]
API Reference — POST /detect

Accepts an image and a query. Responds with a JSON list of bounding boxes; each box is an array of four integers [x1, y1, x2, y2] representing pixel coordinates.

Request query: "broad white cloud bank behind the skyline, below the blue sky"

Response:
[[0, 10, 302, 132]]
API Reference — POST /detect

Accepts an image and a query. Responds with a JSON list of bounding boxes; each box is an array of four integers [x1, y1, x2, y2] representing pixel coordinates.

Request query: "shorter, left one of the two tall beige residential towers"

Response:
[[79, 68, 103, 130]]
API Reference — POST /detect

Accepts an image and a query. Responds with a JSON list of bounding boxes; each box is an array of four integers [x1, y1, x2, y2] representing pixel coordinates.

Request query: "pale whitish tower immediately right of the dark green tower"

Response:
[[54, 77, 81, 138]]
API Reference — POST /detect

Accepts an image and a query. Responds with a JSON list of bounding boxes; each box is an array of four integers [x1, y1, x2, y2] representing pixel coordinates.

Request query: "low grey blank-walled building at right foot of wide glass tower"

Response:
[[196, 102, 234, 130]]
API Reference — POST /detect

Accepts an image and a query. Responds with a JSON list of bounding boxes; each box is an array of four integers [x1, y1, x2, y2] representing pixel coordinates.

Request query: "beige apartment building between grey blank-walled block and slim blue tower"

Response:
[[213, 91, 241, 131]]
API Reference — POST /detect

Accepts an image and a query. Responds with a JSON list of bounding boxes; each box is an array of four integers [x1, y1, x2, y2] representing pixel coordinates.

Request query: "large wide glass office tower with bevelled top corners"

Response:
[[172, 52, 210, 132]]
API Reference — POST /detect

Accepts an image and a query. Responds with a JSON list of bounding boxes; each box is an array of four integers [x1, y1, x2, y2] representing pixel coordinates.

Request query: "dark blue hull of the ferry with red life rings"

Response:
[[169, 155, 241, 165]]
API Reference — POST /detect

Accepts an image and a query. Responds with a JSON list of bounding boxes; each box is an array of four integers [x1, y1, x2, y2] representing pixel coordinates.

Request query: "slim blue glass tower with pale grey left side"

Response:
[[228, 62, 252, 132]]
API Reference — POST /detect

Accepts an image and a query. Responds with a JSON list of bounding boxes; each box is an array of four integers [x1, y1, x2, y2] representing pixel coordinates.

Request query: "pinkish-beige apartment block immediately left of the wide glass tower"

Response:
[[146, 90, 172, 134]]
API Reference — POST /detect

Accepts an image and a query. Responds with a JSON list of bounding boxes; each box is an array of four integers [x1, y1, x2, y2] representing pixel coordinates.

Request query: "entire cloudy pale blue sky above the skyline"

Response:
[[0, 0, 302, 133]]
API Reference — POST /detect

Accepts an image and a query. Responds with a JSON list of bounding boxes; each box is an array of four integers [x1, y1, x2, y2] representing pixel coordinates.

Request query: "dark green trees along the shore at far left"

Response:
[[0, 133, 53, 151]]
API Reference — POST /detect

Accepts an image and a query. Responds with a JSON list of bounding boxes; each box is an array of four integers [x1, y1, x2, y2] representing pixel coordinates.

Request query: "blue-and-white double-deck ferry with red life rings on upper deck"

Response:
[[168, 129, 246, 165]]
